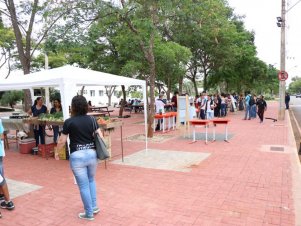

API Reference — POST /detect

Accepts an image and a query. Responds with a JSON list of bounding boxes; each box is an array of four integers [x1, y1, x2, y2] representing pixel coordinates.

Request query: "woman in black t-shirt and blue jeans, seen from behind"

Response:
[[57, 96, 102, 220]]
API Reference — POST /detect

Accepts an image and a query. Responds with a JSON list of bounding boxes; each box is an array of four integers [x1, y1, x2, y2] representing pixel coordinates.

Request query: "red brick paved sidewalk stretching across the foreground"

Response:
[[0, 102, 301, 226]]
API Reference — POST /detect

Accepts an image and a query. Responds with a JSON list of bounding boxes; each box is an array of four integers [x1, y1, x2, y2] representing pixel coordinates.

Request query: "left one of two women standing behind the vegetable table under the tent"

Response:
[[27, 97, 48, 146]]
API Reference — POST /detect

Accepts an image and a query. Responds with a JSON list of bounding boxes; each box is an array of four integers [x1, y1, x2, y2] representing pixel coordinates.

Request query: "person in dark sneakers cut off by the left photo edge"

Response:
[[0, 119, 15, 218]]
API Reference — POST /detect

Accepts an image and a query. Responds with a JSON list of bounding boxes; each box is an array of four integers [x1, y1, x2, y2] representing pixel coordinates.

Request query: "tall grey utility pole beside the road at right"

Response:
[[278, 0, 286, 121]]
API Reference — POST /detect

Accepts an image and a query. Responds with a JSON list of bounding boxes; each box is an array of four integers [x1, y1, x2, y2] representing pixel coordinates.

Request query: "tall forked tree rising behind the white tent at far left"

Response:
[[0, 0, 94, 110]]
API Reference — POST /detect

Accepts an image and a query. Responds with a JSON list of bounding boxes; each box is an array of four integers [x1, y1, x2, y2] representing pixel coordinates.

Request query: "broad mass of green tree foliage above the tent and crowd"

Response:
[[37, 0, 277, 96]]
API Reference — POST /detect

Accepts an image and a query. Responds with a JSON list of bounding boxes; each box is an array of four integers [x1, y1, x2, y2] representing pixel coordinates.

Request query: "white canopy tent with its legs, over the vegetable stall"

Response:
[[0, 65, 147, 149]]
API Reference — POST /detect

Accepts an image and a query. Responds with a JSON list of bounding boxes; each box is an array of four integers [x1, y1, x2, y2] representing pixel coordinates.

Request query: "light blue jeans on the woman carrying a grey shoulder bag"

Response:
[[70, 149, 97, 217]]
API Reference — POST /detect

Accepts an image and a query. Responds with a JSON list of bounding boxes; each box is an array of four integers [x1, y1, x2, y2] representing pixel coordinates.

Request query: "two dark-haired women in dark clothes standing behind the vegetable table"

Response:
[[27, 97, 62, 146]]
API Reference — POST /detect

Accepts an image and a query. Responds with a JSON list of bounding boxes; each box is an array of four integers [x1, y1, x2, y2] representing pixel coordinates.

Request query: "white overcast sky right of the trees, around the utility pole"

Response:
[[228, 0, 301, 83]]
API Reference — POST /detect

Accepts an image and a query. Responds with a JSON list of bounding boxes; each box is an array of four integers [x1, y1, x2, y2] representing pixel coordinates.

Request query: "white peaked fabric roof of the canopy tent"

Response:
[[0, 65, 145, 90]]
